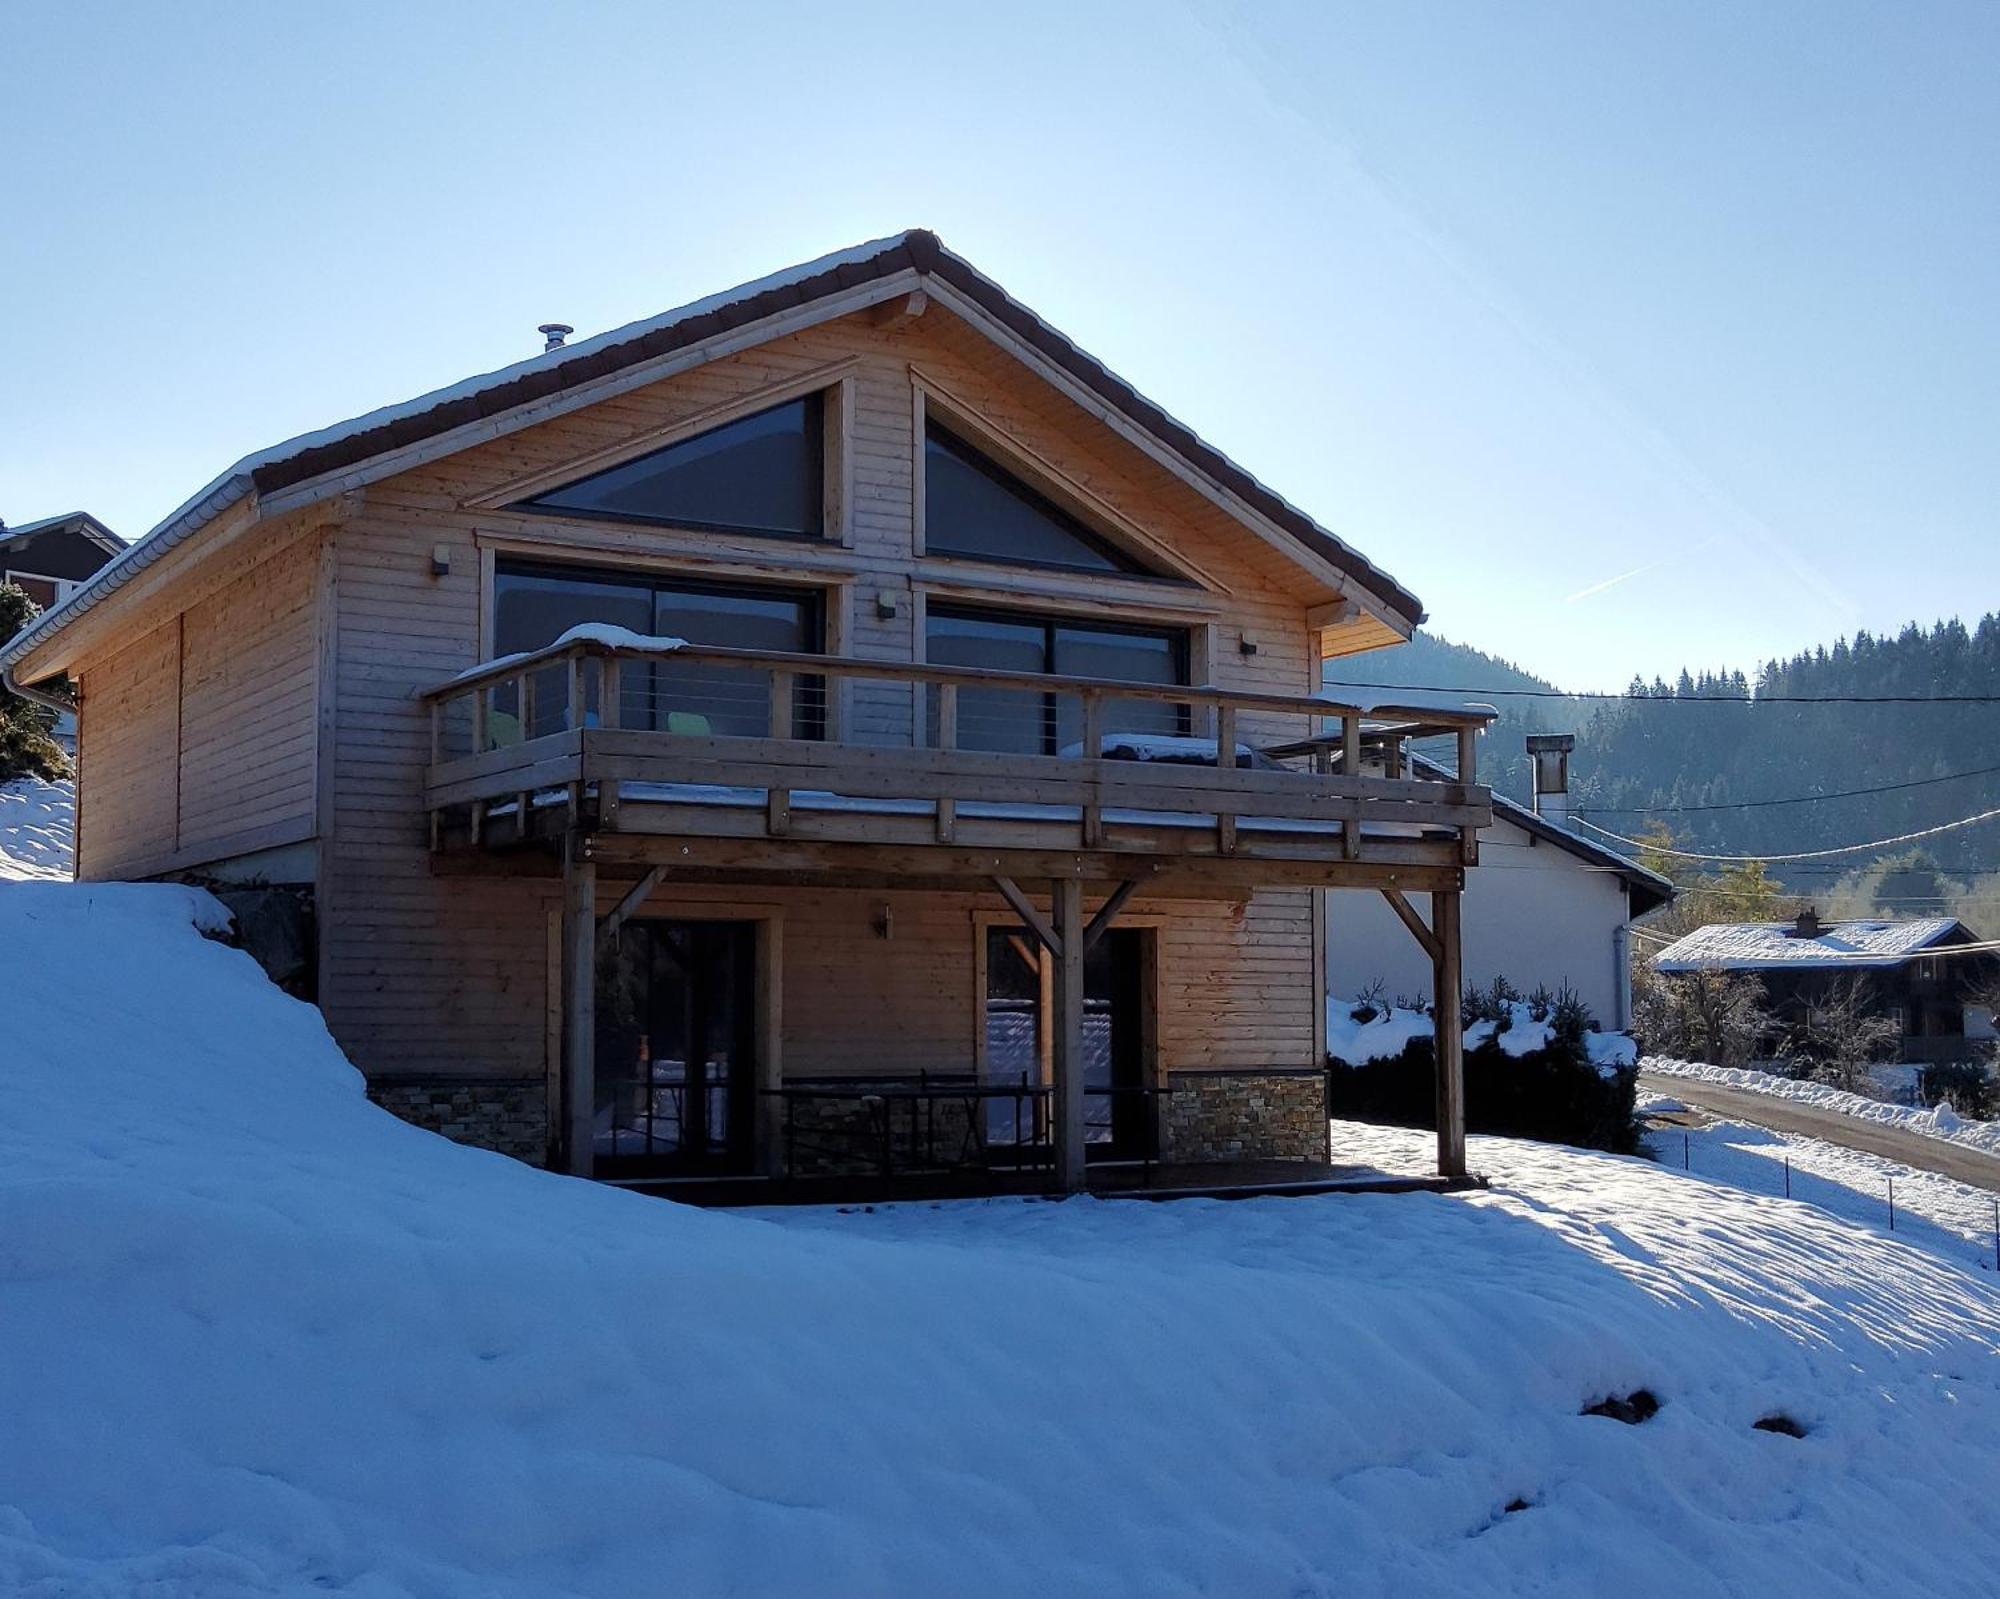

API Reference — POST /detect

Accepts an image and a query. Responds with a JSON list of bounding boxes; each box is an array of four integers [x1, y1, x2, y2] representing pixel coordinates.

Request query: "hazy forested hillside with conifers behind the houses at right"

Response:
[[1328, 616, 2000, 931]]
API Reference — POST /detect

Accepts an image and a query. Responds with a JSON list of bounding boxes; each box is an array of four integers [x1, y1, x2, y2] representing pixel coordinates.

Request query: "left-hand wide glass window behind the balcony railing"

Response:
[[494, 562, 824, 742]]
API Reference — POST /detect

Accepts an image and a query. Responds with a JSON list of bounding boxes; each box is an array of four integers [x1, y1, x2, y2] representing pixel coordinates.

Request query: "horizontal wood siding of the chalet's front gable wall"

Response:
[[308, 308, 1344, 1075]]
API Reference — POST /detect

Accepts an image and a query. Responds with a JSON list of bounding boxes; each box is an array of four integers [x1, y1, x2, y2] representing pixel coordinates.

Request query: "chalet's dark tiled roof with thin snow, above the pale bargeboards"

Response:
[[0, 228, 1424, 687]]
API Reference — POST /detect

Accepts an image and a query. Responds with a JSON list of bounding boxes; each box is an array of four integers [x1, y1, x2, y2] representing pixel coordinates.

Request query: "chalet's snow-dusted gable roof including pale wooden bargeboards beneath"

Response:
[[0, 230, 1424, 684]]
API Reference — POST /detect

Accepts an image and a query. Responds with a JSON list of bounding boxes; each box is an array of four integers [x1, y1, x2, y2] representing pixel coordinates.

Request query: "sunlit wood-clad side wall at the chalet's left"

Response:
[[78, 538, 318, 879]]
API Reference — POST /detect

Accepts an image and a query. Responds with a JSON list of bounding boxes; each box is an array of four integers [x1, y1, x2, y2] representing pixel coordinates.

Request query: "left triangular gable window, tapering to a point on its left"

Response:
[[514, 394, 826, 538]]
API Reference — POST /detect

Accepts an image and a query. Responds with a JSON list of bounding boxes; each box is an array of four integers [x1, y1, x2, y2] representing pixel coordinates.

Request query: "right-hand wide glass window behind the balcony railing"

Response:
[[924, 606, 1190, 756]]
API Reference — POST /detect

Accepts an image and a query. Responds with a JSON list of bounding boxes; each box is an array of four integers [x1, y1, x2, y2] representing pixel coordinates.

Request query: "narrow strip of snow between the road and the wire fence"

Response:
[[1638, 1093, 2000, 1271]]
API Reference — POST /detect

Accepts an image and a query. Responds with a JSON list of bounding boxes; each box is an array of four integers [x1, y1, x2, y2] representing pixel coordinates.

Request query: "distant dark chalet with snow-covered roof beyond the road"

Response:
[[1652, 909, 2000, 1065]]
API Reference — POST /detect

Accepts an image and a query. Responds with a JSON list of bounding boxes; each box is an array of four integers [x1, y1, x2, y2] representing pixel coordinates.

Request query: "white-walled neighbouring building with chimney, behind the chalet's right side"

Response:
[[1326, 740, 1674, 1029]]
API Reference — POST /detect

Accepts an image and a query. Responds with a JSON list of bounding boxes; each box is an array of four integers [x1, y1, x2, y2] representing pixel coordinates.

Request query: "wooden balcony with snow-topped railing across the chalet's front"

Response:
[[422, 638, 1492, 891]]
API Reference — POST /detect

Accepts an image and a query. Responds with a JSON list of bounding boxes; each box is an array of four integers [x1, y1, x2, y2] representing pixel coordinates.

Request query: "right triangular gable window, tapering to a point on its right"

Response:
[[924, 420, 1166, 578]]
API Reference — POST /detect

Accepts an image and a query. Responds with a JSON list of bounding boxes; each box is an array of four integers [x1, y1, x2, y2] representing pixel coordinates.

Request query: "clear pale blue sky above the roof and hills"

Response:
[[0, 0, 2000, 688]]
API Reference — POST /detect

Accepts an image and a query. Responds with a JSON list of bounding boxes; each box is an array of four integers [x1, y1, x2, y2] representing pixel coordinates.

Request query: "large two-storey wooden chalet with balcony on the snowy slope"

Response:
[[0, 232, 1492, 1193]]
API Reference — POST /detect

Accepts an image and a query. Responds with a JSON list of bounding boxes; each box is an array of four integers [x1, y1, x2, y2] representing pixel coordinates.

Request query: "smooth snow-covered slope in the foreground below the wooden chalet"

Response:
[[0, 883, 2000, 1599]]
